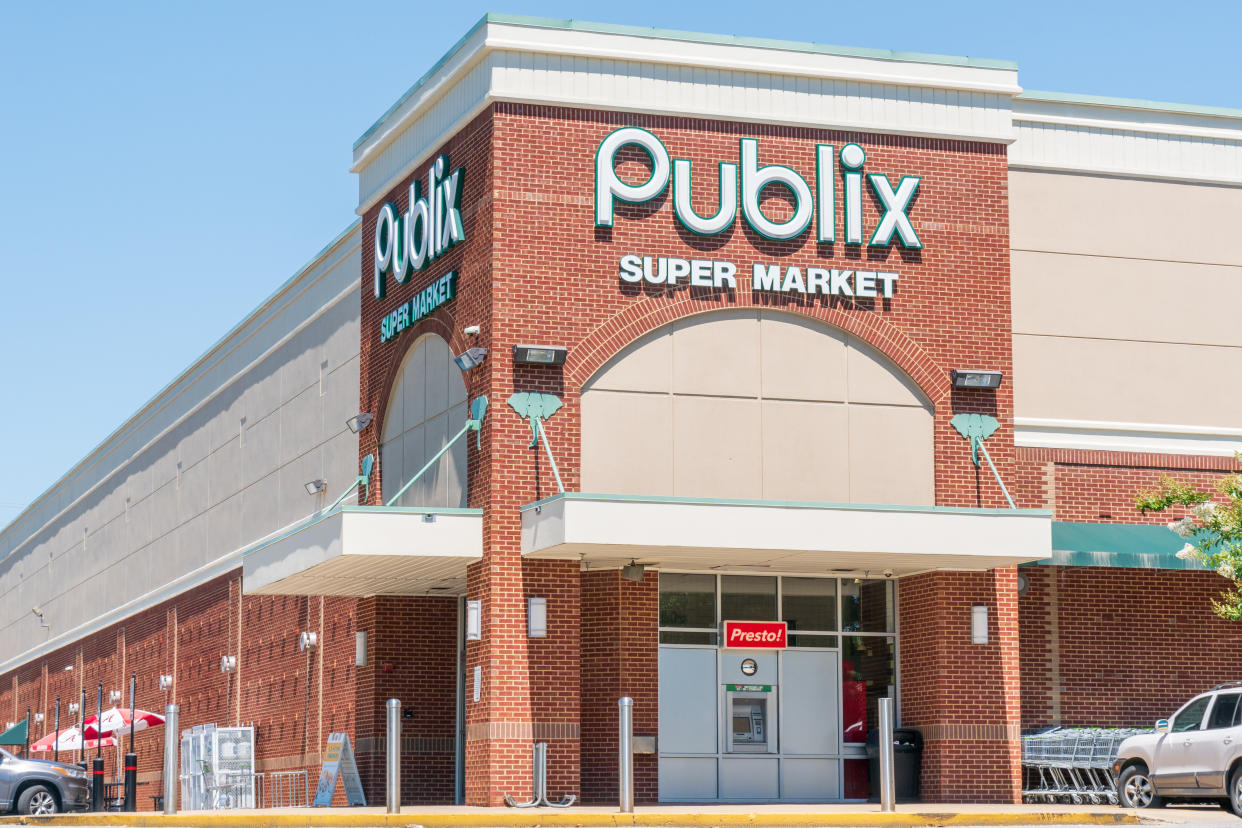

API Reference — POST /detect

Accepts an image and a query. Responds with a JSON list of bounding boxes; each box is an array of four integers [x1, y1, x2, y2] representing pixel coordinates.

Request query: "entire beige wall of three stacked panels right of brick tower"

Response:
[[1010, 170, 1242, 427]]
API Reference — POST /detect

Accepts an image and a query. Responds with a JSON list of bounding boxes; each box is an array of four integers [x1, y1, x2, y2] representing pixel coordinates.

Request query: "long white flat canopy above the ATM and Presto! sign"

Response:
[[522, 493, 1052, 575]]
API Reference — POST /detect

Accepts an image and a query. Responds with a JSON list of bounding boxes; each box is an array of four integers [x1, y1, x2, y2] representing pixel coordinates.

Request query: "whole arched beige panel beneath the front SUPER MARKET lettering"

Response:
[[582, 310, 934, 504]]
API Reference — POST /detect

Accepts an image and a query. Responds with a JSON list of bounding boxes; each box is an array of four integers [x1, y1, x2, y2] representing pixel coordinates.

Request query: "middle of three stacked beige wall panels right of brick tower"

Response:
[[1011, 251, 1242, 346]]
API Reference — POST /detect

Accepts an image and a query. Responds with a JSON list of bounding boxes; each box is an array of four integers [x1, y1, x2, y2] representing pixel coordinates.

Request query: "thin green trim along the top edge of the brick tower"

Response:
[[354, 12, 1017, 149]]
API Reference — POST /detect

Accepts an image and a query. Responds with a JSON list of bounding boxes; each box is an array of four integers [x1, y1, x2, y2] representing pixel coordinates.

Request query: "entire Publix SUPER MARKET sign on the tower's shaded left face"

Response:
[[375, 155, 466, 343]]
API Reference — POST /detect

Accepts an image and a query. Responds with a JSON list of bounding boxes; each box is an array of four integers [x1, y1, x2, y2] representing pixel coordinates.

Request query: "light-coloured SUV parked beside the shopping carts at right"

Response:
[[1113, 682, 1242, 817]]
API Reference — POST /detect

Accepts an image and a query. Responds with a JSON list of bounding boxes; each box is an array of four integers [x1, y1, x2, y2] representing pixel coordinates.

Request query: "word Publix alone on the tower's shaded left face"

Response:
[[375, 155, 466, 299]]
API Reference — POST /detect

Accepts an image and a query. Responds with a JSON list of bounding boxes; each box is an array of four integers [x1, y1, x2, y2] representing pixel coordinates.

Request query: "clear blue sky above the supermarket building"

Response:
[[0, 0, 1242, 524]]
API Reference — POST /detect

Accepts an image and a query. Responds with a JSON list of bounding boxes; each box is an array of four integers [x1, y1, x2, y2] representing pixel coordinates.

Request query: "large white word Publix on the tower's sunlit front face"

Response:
[[595, 127, 923, 248]]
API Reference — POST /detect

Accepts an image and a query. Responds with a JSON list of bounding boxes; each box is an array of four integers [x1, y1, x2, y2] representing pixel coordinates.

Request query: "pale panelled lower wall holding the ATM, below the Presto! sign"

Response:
[[660, 646, 842, 802]]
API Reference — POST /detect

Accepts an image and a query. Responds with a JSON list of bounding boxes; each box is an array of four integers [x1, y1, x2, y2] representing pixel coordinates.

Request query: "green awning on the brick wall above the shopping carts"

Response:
[[1030, 520, 1203, 570]]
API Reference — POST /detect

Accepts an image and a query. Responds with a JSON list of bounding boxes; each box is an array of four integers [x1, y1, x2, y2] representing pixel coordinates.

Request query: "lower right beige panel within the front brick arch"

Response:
[[850, 406, 935, 505]]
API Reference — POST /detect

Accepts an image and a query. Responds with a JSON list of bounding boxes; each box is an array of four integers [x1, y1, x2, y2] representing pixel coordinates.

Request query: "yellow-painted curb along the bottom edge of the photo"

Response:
[[0, 811, 1141, 828]]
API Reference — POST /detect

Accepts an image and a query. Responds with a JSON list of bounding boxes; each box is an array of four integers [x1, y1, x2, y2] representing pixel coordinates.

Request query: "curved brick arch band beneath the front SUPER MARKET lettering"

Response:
[[565, 293, 951, 411]]
